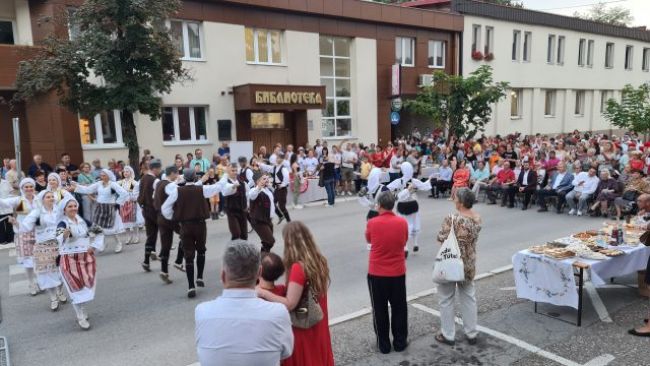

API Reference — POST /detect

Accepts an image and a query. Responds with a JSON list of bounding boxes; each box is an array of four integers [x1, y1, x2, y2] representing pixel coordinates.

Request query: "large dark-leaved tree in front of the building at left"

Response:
[[14, 0, 189, 171]]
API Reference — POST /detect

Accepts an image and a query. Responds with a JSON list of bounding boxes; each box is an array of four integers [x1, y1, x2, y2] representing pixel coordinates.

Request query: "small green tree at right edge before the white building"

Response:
[[604, 83, 650, 134]]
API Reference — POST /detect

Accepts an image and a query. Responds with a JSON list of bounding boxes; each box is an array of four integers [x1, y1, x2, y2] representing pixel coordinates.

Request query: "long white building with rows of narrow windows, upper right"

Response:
[[403, 0, 650, 134]]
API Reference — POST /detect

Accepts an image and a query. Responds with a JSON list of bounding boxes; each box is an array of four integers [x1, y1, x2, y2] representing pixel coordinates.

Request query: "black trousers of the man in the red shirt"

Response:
[[368, 274, 408, 353]]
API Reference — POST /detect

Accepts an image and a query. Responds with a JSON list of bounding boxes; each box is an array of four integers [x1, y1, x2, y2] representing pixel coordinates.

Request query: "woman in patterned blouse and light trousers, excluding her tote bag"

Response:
[[435, 188, 481, 346]]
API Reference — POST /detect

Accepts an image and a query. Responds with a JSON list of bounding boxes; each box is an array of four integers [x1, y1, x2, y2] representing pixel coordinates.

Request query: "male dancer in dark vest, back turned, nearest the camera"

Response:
[[157, 169, 221, 298]]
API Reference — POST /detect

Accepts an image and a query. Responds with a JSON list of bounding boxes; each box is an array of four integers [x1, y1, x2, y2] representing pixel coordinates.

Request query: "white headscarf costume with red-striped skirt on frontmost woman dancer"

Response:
[[57, 198, 104, 330]]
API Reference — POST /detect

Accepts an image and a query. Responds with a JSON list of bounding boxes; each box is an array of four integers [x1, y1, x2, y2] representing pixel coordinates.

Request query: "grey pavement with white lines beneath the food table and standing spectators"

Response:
[[331, 272, 650, 366]]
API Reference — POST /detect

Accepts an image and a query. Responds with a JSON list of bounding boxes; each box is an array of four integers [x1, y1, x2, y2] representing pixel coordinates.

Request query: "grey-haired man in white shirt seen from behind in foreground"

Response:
[[194, 241, 293, 366]]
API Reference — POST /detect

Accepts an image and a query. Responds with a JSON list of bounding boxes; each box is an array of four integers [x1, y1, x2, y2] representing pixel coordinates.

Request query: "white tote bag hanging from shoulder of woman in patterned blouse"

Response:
[[433, 216, 465, 283]]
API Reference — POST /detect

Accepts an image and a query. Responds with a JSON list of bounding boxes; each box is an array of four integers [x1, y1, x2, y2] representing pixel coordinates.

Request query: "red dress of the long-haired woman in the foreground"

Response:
[[282, 263, 334, 366]]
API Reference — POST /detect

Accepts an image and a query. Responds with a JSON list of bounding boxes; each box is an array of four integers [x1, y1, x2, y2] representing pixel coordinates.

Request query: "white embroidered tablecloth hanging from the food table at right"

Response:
[[512, 245, 650, 309]]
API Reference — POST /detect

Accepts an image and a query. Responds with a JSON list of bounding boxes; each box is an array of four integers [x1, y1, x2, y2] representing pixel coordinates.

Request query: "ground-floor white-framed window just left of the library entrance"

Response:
[[162, 107, 208, 142]]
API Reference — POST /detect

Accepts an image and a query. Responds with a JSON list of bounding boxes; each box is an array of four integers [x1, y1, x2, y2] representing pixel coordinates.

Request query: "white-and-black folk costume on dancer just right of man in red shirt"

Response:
[[388, 162, 431, 256]]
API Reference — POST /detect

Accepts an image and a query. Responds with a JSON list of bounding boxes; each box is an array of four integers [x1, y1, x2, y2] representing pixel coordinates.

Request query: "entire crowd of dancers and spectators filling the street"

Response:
[[0, 129, 650, 365]]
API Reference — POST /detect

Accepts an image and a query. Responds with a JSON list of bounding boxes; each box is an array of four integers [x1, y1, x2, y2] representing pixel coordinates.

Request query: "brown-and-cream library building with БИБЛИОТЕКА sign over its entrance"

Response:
[[0, 0, 463, 167]]
